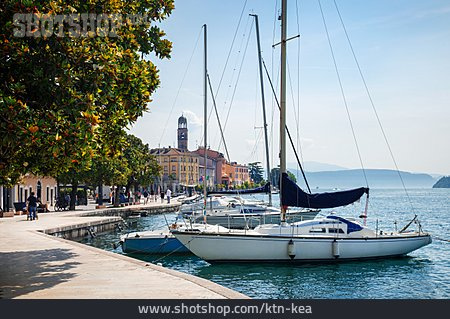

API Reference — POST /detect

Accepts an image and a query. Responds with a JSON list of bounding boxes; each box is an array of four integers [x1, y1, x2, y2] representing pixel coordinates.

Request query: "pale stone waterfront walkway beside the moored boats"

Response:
[[0, 202, 247, 299]]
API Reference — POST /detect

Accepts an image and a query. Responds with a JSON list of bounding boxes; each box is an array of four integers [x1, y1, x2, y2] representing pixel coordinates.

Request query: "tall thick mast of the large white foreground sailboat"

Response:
[[280, 0, 287, 222]]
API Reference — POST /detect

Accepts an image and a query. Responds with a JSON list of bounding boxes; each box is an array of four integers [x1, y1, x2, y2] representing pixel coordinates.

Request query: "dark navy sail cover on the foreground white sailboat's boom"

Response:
[[281, 173, 369, 208]]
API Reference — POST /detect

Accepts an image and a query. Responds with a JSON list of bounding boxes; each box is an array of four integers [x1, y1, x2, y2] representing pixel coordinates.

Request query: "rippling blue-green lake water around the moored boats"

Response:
[[84, 189, 450, 299]]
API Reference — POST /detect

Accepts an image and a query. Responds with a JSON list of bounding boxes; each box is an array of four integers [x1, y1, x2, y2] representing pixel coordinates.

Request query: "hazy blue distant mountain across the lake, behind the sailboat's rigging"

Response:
[[289, 168, 436, 189]]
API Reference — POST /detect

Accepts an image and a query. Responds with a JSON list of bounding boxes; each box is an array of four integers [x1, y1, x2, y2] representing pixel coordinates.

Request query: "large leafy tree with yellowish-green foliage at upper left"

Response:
[[0, 0, 174, 186]]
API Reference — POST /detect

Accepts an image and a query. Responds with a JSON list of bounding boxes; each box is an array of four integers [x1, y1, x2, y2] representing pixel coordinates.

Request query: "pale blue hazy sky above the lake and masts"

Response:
[[130, 0, 450, 175]]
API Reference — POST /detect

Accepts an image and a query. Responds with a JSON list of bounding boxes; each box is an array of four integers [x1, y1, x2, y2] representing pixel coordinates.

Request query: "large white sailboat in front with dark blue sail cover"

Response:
[[172, 0, 431, 262]]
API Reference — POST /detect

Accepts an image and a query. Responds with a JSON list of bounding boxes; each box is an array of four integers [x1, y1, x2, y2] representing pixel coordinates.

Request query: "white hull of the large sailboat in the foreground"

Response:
[[174, 232, 431, 262]]
